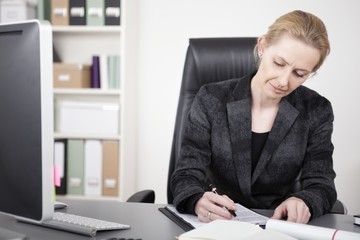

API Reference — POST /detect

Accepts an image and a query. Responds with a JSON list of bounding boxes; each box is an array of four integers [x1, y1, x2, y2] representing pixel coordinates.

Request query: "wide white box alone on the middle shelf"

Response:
[[55, 100, 120, 136]]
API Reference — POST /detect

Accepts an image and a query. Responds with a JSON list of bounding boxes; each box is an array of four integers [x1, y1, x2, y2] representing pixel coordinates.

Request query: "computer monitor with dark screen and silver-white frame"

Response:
[[0, 20, 54, 228]]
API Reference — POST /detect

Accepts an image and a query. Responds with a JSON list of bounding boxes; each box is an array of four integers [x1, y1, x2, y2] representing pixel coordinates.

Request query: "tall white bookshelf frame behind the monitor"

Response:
[[53, 0, 138, 201]]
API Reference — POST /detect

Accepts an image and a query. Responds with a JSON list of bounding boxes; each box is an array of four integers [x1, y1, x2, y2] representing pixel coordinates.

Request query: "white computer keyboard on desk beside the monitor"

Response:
[[40, 212, 130, 237]]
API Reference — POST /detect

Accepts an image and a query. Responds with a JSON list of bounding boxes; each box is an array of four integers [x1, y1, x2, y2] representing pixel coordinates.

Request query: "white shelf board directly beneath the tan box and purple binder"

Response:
[[54, 88, 121, 96]]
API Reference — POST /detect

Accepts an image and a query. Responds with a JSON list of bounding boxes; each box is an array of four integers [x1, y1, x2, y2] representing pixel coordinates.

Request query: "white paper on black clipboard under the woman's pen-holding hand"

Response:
[[165, 203, 269, 228]]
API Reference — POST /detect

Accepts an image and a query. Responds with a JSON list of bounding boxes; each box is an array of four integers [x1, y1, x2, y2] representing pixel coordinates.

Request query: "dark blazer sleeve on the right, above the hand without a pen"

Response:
[[292, 97, 337, 218]]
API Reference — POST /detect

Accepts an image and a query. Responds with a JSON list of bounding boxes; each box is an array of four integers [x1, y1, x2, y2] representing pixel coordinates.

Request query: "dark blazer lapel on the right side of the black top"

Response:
[[252, 99, 299, 184]]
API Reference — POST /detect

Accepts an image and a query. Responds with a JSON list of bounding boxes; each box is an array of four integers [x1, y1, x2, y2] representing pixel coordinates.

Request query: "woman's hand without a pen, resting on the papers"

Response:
[[272, 197, 311, 223]]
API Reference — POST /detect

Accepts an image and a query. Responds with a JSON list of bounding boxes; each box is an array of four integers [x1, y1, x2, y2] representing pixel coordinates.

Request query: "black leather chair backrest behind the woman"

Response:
[[167, 37, 256, 204]]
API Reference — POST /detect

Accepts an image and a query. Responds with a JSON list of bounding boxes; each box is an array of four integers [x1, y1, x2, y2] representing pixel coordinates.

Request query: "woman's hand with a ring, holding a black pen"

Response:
[[195, 192, 236, 222]]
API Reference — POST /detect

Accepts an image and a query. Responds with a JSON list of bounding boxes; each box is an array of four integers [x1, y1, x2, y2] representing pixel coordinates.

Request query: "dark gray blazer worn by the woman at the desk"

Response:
[[171, 76, 337, 217]]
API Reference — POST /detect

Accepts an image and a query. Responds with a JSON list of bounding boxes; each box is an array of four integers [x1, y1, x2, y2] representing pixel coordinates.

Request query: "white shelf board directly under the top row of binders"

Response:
[[52, 26, 122, 33]]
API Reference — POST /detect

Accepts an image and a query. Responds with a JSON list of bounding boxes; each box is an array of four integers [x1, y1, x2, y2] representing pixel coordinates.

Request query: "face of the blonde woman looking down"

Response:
[[255, 34, 320, 99]]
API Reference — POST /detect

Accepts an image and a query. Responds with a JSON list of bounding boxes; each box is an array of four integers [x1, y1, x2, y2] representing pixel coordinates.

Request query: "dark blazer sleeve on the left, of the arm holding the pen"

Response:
[[171, 88, 211, 213]]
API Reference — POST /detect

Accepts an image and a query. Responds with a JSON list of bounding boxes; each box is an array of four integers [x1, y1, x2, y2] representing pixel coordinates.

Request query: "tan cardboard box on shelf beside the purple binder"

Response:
[[54, 63, 91, 88]]
